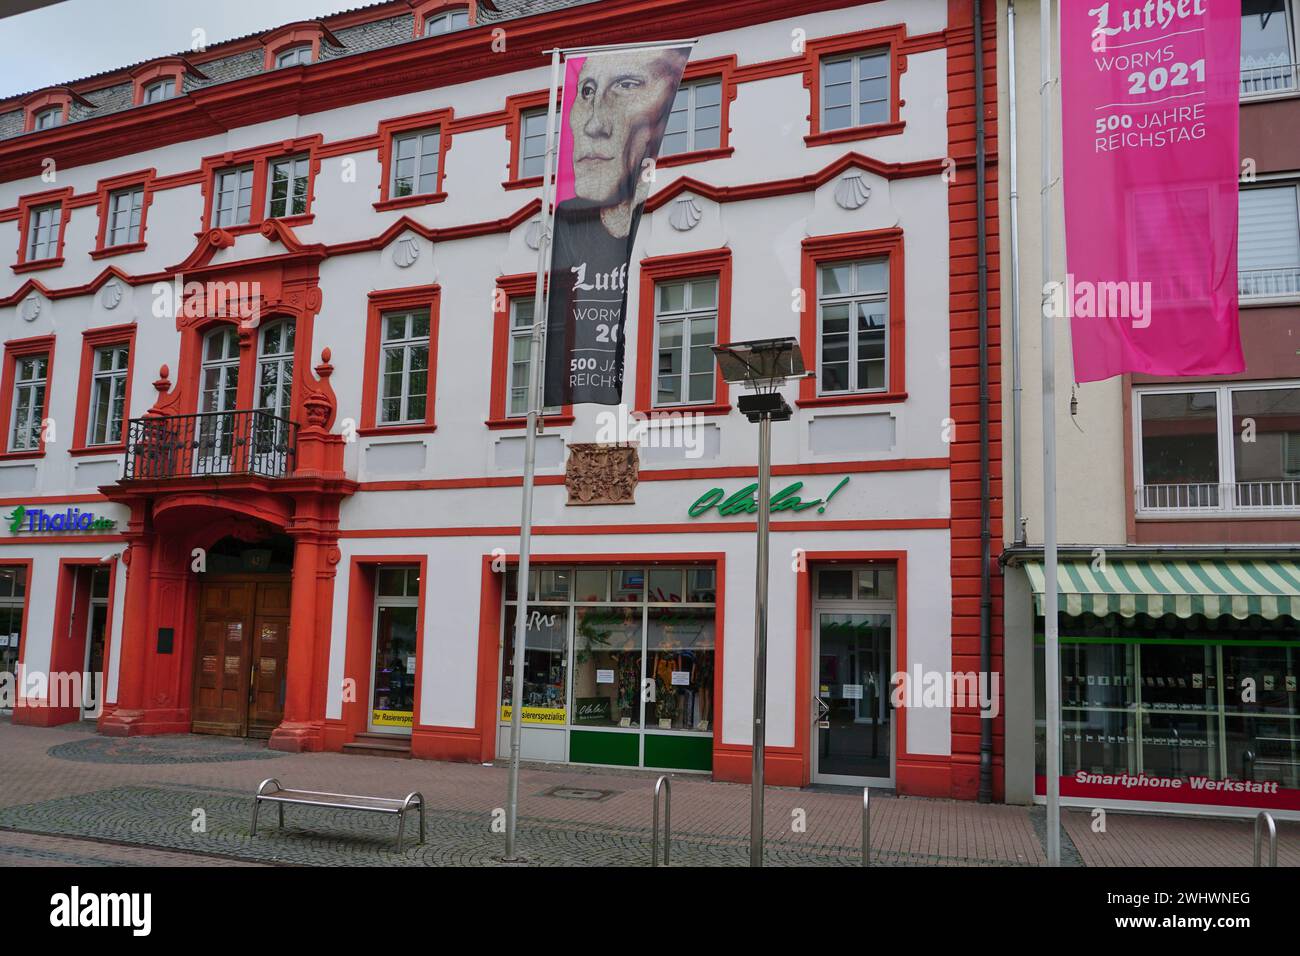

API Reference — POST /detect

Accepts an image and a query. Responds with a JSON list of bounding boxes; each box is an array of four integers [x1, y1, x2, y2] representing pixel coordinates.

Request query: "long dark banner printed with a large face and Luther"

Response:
[[543, 47, 690, 407]]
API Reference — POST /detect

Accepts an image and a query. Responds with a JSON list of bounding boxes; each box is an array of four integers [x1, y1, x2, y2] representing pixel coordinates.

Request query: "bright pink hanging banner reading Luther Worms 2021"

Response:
[[1050, 0, 1245, 382]]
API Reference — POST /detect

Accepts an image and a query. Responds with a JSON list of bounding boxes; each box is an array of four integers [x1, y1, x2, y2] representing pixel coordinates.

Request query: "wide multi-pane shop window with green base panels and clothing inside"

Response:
[[501, 567, 716, 770]]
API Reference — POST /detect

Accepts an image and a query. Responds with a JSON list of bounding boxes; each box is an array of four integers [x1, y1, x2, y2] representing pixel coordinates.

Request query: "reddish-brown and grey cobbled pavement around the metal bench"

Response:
[[0, 721, 1300, 866]]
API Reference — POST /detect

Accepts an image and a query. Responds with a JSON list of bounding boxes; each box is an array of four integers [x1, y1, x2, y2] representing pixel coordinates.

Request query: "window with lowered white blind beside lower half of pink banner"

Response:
[[1236, 183, 1300, 298]]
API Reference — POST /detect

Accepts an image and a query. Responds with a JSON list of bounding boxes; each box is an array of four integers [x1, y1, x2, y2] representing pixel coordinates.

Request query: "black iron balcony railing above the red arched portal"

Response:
[[122, 408, 298, 481]]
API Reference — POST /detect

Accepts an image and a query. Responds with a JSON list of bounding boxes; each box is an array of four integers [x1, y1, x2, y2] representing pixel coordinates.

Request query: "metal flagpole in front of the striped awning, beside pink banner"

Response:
[[1039, 0, 1069, 866]]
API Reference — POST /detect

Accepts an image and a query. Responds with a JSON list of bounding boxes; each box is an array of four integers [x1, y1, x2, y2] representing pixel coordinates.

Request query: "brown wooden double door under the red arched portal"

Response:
[[192, 575, 291, 737]]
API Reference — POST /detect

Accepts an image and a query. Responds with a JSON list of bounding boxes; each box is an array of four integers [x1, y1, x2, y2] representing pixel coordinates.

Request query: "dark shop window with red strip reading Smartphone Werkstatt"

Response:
[[1036, 614, 1300, 809]]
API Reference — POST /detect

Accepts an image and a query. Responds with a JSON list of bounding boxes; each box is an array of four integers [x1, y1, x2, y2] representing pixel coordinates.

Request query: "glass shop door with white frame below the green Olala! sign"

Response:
[[813, 609, 893, 786]]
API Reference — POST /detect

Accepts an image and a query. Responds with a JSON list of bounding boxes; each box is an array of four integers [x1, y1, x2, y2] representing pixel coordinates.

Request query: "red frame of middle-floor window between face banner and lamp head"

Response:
[[636, 248, 732, 418]]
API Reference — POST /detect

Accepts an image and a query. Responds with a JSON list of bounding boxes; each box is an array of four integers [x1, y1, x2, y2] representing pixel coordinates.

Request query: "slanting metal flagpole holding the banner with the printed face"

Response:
[[506, 49, 560, 862]]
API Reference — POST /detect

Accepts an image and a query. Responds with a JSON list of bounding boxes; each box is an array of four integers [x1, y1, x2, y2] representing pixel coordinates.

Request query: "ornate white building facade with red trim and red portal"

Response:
[[0, 0, 1002, 799]]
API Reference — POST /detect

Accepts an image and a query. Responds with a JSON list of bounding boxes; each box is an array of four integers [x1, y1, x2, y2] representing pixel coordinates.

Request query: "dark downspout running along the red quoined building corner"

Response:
[[972, 0, 993, 804]]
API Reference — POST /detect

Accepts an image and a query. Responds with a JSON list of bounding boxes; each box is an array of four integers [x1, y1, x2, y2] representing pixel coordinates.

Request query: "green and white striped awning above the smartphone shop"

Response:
[[1024, 558, 1300, 620]]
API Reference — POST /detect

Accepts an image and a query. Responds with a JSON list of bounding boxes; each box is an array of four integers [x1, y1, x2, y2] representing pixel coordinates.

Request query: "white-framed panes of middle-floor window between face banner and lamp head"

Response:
[[654, 278, 718, 406]]
